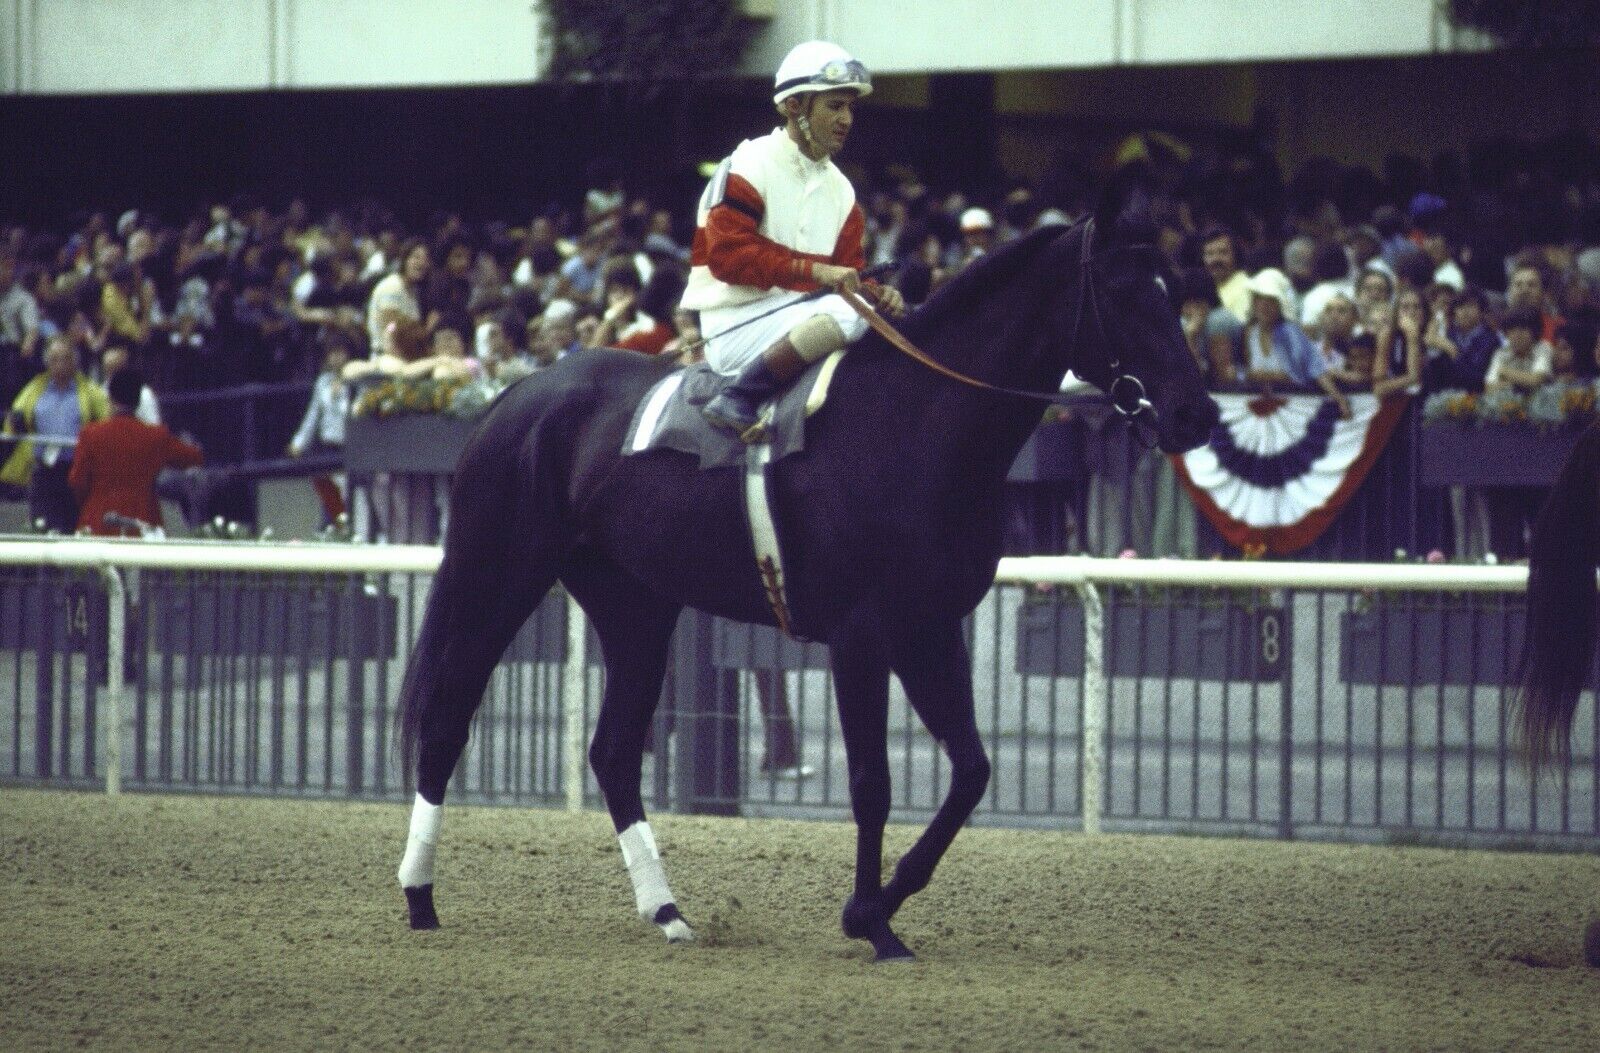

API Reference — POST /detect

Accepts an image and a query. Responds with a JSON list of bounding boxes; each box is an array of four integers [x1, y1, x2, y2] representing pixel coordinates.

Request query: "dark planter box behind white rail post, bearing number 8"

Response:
[[1016, 588, 1290, 682]]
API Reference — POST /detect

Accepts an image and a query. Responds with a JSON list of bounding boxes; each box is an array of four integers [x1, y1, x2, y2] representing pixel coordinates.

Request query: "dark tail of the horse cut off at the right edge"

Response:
[[1515, 427, 1600, 779]]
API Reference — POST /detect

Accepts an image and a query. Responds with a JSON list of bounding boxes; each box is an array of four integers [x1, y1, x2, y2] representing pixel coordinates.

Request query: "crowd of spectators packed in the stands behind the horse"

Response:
[[0, 132, 1600, 550]]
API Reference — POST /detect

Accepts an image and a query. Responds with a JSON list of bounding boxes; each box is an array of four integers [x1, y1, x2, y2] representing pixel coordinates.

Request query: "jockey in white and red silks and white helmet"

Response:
[[683, 40, 906, 442]]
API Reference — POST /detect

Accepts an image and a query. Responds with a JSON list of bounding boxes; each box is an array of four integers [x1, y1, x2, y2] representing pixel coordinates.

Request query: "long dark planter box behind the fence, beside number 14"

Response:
[[144, 581, 400, 659]]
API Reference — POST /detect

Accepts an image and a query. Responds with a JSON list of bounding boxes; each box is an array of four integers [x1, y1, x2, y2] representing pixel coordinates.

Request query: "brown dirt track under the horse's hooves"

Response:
[[0, 791, 1600, 1053]]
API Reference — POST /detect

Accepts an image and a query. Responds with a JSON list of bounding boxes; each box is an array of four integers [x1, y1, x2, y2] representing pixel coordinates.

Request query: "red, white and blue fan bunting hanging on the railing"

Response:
[[1173, 395, 1410, 555]]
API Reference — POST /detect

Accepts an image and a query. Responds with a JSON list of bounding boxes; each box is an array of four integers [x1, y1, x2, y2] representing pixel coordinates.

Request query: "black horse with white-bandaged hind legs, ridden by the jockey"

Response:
[[398, 194, 1218, 960]]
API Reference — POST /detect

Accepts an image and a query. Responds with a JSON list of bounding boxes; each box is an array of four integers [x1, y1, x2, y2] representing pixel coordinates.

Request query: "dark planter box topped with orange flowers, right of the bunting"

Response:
[[1421, 421, 1584, 486]]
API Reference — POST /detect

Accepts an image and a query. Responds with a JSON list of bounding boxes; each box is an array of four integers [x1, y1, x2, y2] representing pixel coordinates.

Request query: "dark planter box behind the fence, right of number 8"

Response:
[[1339, 602, 1528, 687]]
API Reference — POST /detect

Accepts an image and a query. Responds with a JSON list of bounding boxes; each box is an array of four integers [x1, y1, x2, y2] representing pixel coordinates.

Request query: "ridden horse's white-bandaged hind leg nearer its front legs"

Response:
[[562, 555, 694, 943]]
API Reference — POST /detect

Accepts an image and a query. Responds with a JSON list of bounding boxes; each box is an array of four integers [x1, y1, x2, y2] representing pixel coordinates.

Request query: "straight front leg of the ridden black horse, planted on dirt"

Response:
[[832, 615, 912, 962]]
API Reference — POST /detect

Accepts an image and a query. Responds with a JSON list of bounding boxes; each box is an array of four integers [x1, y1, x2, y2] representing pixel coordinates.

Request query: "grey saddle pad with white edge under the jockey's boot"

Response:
[[622, 350, 845, 469]]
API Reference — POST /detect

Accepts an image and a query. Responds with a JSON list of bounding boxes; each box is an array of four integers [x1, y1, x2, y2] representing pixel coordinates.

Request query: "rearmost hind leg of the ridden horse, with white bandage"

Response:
[[397, 555, 555, 928]]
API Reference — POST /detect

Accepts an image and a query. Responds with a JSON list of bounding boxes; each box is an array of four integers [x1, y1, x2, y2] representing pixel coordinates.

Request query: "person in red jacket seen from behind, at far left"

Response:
[[69, 368, 202, 536]]
